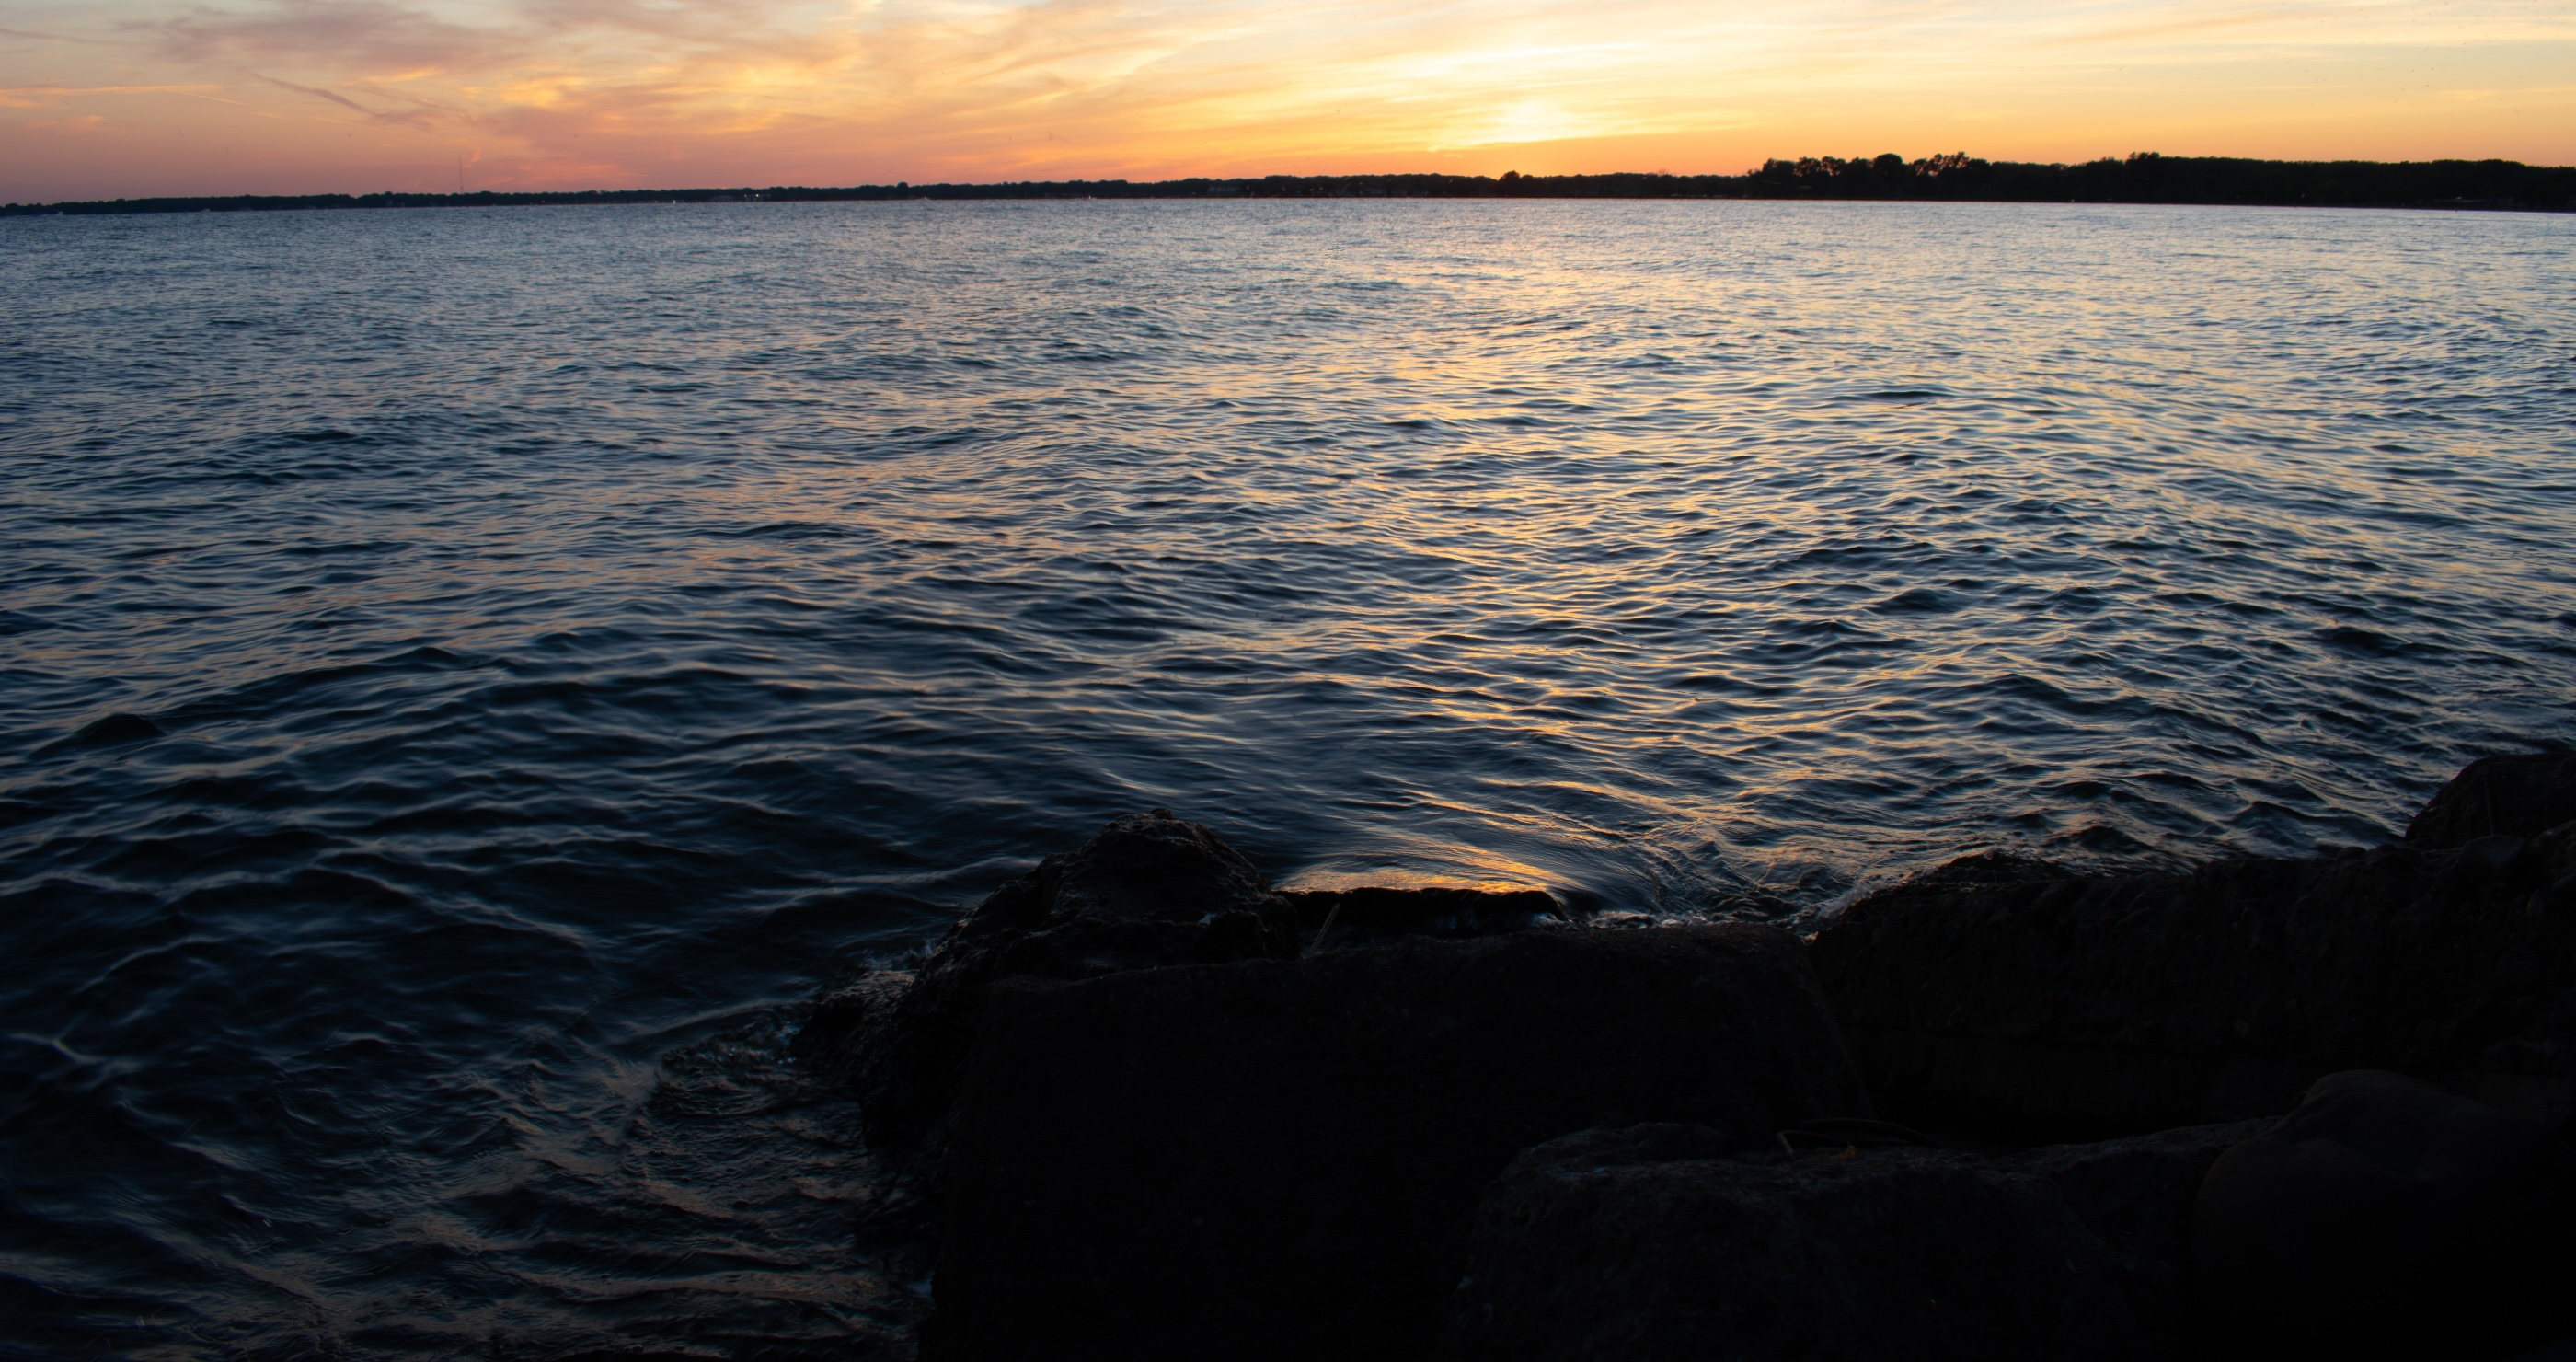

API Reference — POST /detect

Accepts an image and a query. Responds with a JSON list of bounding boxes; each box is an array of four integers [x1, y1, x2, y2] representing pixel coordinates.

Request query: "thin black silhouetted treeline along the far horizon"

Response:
[[0, 152, 2576, 216]]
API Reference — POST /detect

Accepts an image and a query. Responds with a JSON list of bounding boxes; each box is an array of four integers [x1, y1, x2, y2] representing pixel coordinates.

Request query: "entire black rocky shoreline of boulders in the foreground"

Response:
[[799, 755, 2576, 1362]]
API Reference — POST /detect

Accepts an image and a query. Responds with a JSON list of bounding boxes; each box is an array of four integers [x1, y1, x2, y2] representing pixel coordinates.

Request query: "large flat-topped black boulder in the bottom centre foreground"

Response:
[[922, 927, 1865, 1359]]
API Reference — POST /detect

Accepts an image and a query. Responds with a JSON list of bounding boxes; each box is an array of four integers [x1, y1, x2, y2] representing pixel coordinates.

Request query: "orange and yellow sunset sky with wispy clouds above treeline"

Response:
[[0, 0, 2576, 201]]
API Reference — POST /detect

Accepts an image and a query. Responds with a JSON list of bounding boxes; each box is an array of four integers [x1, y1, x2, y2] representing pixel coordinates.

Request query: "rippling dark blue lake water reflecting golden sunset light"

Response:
[[0, 201, 2576, 1359]]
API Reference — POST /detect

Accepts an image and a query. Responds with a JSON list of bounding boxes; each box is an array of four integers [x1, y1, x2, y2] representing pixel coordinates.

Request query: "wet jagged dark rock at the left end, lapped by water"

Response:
[[801, 808, 1298, 1148]]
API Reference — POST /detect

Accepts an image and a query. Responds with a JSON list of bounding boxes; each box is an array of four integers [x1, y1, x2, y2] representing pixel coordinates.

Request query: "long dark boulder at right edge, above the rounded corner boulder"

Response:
[[1813, 808, 2576, 1136]]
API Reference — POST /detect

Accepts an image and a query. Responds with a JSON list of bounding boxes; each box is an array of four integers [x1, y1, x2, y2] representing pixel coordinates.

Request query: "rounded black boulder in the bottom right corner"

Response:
[[2192, 1071, 2576, 1362]]
